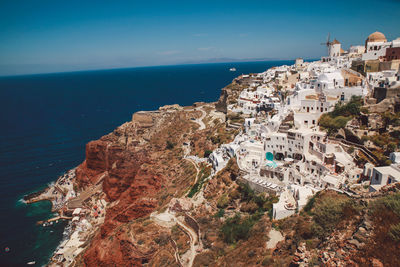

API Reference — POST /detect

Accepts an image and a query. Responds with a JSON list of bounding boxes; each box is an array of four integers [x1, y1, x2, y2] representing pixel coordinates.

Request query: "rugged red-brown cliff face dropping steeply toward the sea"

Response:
[[72, 109, 209, 266]]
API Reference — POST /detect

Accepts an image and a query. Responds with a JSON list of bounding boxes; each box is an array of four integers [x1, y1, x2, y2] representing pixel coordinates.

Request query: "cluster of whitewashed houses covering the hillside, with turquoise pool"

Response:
[[210, 33, 400, 219]]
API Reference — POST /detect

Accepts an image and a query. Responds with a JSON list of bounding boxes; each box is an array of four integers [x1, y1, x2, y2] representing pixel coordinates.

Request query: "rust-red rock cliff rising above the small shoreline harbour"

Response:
[[76, 112, 198, 266]]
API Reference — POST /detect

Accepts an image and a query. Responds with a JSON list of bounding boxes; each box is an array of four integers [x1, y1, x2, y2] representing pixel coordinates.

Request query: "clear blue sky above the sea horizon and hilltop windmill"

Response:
[[0, 0, 400, 76]]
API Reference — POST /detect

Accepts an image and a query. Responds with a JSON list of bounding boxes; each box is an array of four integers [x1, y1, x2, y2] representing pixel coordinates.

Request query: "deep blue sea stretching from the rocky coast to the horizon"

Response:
[[0, 61, 293, 266]]
